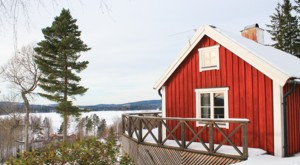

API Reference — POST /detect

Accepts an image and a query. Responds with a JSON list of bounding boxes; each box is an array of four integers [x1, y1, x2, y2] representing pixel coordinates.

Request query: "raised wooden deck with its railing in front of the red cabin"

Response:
[[122, 113, 249, 165]]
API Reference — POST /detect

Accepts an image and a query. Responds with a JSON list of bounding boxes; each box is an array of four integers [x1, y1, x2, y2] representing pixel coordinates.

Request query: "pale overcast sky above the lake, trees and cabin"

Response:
[[0, 0, 283, 105]]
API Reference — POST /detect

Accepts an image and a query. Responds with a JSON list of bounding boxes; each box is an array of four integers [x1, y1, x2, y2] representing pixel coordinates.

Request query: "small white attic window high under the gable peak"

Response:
[[198, 45, 220, 72]]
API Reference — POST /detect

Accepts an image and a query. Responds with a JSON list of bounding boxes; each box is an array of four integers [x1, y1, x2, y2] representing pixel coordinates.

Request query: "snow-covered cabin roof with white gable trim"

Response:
[[154, 25, 300, 90]]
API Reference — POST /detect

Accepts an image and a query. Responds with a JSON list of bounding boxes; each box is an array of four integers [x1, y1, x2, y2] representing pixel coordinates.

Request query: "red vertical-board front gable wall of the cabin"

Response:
[[164, 36, 274, 154]]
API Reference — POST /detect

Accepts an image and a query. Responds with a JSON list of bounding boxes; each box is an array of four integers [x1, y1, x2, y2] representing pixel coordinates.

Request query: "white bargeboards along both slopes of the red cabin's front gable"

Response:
[[153, 25, 290, 90]]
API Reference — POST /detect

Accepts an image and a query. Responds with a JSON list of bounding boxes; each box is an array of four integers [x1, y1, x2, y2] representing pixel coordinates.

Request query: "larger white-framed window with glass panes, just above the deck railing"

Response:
[[195, 87, 228, 128]]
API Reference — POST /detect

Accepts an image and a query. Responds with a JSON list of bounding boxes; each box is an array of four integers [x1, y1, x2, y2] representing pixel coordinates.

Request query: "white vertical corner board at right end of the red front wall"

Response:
[[273, 81, 284, 157]]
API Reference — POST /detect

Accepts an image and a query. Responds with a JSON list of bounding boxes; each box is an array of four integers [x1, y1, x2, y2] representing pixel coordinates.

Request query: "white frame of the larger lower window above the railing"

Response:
[[195, 87, 229, 129]]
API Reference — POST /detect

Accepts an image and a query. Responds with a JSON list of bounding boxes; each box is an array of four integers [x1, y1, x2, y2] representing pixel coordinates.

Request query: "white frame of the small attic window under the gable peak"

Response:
[[198, 45, 220, 72]]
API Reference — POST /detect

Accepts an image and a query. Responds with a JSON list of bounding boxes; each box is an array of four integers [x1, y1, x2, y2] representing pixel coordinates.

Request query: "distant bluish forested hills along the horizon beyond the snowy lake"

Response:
[[0, 100, 161, 115]]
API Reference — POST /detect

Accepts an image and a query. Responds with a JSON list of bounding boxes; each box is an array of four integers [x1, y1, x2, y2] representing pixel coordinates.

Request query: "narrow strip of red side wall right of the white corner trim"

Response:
[[283, 84, 300, 155]]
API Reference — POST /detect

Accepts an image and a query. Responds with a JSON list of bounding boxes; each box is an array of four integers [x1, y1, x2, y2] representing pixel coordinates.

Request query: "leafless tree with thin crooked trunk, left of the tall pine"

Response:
[[1, 46, 40, 151]]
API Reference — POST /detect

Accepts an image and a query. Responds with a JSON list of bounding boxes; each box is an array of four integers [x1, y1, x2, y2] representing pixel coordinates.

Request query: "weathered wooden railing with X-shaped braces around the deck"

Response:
[[122, 112, 249, 160]]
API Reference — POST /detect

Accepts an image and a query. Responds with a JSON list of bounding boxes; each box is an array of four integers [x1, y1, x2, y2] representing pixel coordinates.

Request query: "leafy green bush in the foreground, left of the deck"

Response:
[[6, 138, 133, 165]]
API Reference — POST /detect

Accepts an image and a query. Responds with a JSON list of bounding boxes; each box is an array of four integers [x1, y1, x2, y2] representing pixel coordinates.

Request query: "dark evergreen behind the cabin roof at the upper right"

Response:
[[267, 0, 300, 57]]
